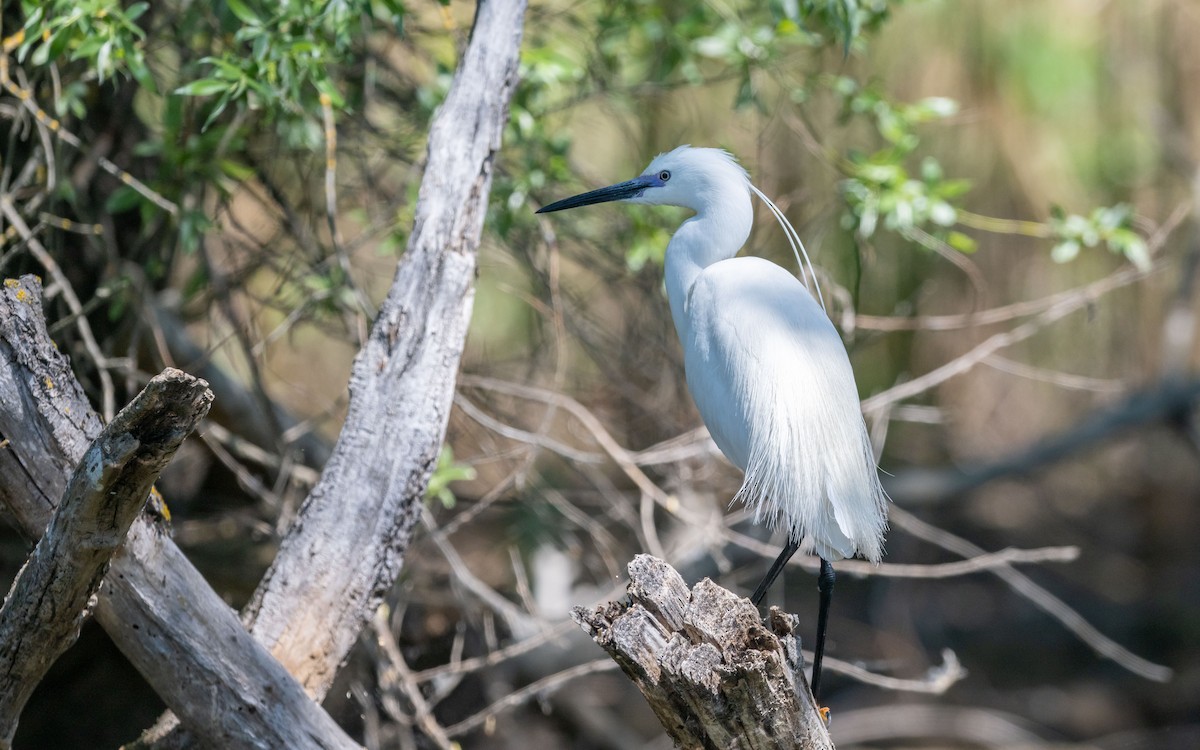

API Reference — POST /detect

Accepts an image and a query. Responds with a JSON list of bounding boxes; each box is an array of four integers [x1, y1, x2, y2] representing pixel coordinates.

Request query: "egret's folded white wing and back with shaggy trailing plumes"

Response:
[[684, 258, 887, 560]]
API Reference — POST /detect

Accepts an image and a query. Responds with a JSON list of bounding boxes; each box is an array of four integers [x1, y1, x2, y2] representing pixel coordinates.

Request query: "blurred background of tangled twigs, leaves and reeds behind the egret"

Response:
[[0, 0, 1200, 749]]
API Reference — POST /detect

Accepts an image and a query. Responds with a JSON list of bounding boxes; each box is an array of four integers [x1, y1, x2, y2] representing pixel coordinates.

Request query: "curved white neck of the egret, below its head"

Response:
[[664, 194, 754, 338]]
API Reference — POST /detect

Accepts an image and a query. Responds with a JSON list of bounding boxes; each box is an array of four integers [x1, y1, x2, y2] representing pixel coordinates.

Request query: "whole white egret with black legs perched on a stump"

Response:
[[538, 146, 887, 695]]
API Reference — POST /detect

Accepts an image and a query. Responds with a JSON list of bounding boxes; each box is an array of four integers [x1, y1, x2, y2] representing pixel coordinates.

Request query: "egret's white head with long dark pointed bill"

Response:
[[538, 146, 750, 214]]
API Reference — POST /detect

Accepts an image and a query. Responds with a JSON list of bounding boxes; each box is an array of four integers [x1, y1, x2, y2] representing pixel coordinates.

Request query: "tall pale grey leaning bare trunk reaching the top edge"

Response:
[[238, 0, 526, 697]]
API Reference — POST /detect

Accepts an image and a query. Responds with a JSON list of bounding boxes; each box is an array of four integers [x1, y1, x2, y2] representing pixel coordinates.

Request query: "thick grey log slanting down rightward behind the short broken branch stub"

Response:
[[0, 276, 355, 748]]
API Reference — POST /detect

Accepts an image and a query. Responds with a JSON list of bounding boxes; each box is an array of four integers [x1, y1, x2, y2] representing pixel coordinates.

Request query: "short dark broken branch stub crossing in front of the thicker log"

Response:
[[0, 370, 212, 746]]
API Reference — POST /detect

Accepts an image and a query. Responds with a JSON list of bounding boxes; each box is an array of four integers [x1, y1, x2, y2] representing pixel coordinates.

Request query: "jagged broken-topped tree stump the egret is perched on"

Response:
[[571, 554, 833, 750]]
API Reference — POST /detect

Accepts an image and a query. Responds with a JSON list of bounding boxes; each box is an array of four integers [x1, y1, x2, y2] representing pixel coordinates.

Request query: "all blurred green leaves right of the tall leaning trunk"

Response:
[[492, 0, 1148, 282]]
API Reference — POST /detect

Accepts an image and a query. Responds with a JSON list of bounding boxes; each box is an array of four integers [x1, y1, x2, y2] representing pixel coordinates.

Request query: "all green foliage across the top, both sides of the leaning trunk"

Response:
[[11, 0, 1146, 331]]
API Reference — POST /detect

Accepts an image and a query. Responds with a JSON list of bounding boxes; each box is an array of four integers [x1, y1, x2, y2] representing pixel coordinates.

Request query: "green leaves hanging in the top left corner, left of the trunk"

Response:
[[18, 0, 404, 265]]
